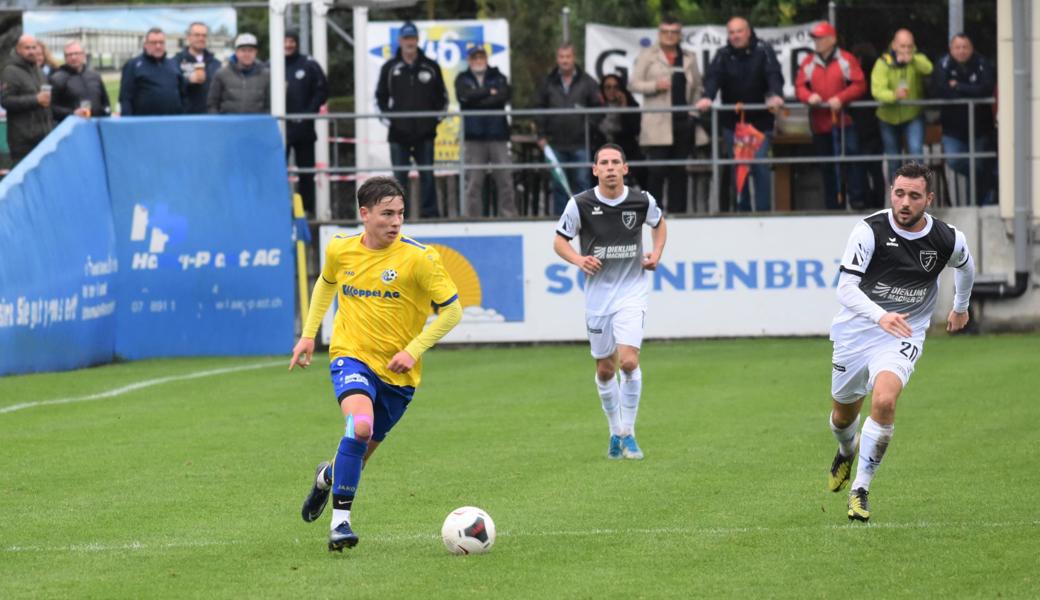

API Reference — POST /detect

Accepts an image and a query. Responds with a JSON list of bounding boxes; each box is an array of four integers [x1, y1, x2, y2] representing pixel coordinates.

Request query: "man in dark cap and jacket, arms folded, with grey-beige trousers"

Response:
[[456, 46, 517, 218]]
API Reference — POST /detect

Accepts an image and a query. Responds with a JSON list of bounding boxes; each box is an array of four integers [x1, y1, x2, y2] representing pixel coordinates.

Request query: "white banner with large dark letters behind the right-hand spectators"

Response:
[[583, 22, 816, 102]]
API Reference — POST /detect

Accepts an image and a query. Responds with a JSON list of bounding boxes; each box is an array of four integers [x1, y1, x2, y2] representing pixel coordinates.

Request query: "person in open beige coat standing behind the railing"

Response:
[[628, 17, 702, 213]]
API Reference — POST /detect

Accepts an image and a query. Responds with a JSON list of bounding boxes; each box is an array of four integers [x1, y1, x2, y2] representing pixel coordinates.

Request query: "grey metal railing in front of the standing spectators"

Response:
[[281, 98, 996, 216]]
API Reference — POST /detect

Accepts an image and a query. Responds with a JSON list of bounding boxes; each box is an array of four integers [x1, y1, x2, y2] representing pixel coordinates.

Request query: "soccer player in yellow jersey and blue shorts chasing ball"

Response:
[[289, 177, 462, 551]]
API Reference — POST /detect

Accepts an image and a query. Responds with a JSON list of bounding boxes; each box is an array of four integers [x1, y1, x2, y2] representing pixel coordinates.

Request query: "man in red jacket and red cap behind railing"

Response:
[[795, 21, 866, 210]]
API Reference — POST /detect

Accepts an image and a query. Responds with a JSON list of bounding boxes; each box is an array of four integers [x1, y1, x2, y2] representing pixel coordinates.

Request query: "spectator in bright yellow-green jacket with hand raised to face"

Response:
[[870, 29, 932, 182]]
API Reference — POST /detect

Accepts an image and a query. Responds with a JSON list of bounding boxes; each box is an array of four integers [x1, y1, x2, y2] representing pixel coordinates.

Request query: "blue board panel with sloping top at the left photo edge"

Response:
[[0, 119, 119, 375]]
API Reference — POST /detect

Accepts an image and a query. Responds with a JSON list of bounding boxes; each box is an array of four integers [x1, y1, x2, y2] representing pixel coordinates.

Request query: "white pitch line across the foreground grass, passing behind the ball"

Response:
[[0, 520, 1040, 553]]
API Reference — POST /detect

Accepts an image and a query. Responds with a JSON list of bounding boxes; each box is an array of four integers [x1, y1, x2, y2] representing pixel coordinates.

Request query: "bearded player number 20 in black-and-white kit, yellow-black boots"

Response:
[[828, 162, 974, 521]]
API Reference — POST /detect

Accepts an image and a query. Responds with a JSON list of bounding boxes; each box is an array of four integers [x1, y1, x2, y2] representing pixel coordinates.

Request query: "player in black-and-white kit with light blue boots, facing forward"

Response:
[[553, 144, 668, 459]]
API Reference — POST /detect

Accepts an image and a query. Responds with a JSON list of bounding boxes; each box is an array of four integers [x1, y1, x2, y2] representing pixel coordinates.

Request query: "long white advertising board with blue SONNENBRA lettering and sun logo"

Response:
[[319, 215, 862, 343]]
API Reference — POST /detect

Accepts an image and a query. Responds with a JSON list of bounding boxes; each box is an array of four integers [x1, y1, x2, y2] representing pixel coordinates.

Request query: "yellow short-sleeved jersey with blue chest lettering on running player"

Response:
[[321, 234, 459, 387]]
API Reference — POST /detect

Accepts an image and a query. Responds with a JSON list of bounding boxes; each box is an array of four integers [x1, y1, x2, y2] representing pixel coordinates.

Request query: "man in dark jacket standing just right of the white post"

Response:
[[285, 31, 329, 214]]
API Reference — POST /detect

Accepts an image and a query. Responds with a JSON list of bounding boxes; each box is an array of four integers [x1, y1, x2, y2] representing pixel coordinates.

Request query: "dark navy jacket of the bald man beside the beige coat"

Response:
[[704, 31, 783, 132]]
